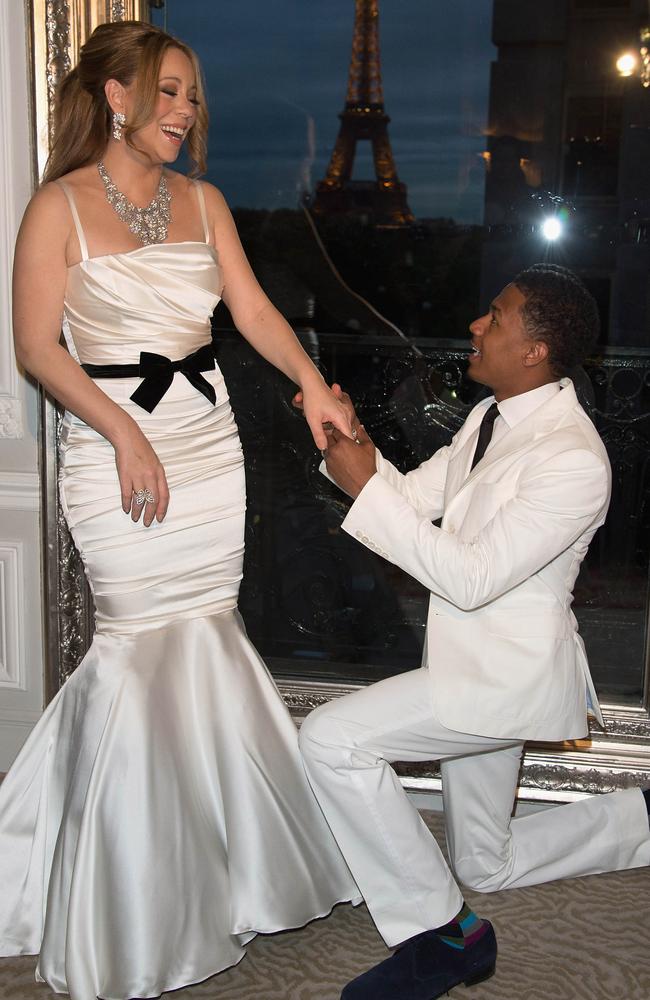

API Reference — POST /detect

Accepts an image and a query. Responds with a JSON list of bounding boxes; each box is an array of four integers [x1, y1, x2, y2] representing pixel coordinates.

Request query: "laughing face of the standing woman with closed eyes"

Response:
[[115, 48, 198, 163]]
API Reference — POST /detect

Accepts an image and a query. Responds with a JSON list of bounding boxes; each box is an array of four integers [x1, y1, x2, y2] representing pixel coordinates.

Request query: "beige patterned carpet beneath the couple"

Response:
[[0, 813, 650, 1000]]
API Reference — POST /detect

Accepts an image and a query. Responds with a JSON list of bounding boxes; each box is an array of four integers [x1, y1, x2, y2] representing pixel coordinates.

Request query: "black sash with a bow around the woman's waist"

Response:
[[81, 337, 217, 413]]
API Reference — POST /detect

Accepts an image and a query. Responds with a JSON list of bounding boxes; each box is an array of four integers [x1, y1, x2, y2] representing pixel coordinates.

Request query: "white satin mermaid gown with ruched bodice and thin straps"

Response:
[[0, 186, 358, 1000]]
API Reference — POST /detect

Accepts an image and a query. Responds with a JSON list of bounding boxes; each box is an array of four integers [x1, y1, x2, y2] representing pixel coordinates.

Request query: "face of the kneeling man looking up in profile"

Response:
[[467, 285, 555, 402]]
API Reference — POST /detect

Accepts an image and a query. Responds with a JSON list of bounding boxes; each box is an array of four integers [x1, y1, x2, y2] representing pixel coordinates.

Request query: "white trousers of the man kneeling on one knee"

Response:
[[300, 669, 650, 947]]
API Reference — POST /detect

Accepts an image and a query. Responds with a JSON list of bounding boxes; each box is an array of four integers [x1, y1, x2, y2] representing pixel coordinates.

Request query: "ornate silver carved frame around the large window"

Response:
[[26, 0, 650, 802]]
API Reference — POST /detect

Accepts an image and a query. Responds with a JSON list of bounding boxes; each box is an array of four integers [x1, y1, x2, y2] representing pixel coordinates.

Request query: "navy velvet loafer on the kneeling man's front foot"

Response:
[[341, 920, 497, 1000]]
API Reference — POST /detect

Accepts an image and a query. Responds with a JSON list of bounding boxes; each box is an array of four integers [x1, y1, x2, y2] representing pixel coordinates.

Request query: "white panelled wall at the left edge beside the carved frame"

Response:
[[0, 0, 43, 771]]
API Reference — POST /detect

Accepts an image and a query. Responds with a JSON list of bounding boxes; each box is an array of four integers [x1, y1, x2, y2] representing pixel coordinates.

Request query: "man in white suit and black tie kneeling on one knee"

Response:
[[300, 265, 650, 1000]]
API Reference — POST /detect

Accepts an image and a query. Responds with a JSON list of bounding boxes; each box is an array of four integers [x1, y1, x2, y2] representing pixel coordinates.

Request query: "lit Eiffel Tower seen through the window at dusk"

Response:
[[312, 0, 413, 226]]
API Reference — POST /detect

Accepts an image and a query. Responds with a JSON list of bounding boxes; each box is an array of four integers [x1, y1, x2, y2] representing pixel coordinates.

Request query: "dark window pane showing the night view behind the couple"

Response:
[[155, 0, 650, 702]]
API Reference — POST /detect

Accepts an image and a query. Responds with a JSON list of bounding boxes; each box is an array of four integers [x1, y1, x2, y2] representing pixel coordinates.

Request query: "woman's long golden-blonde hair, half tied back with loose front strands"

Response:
[[43, 21, 208, 183]]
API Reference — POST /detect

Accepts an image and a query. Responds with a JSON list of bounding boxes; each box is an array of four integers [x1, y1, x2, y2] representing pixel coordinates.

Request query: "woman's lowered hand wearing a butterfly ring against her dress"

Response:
[[115, 424, 169, 528]]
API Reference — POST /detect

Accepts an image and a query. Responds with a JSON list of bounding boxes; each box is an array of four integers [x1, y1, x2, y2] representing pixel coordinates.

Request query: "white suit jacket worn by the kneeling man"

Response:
[[336, 379, 611, 740]]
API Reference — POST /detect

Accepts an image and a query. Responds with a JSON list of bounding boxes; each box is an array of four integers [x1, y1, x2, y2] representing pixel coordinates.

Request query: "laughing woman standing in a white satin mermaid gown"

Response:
[[0, 22, 356, 1000]]
